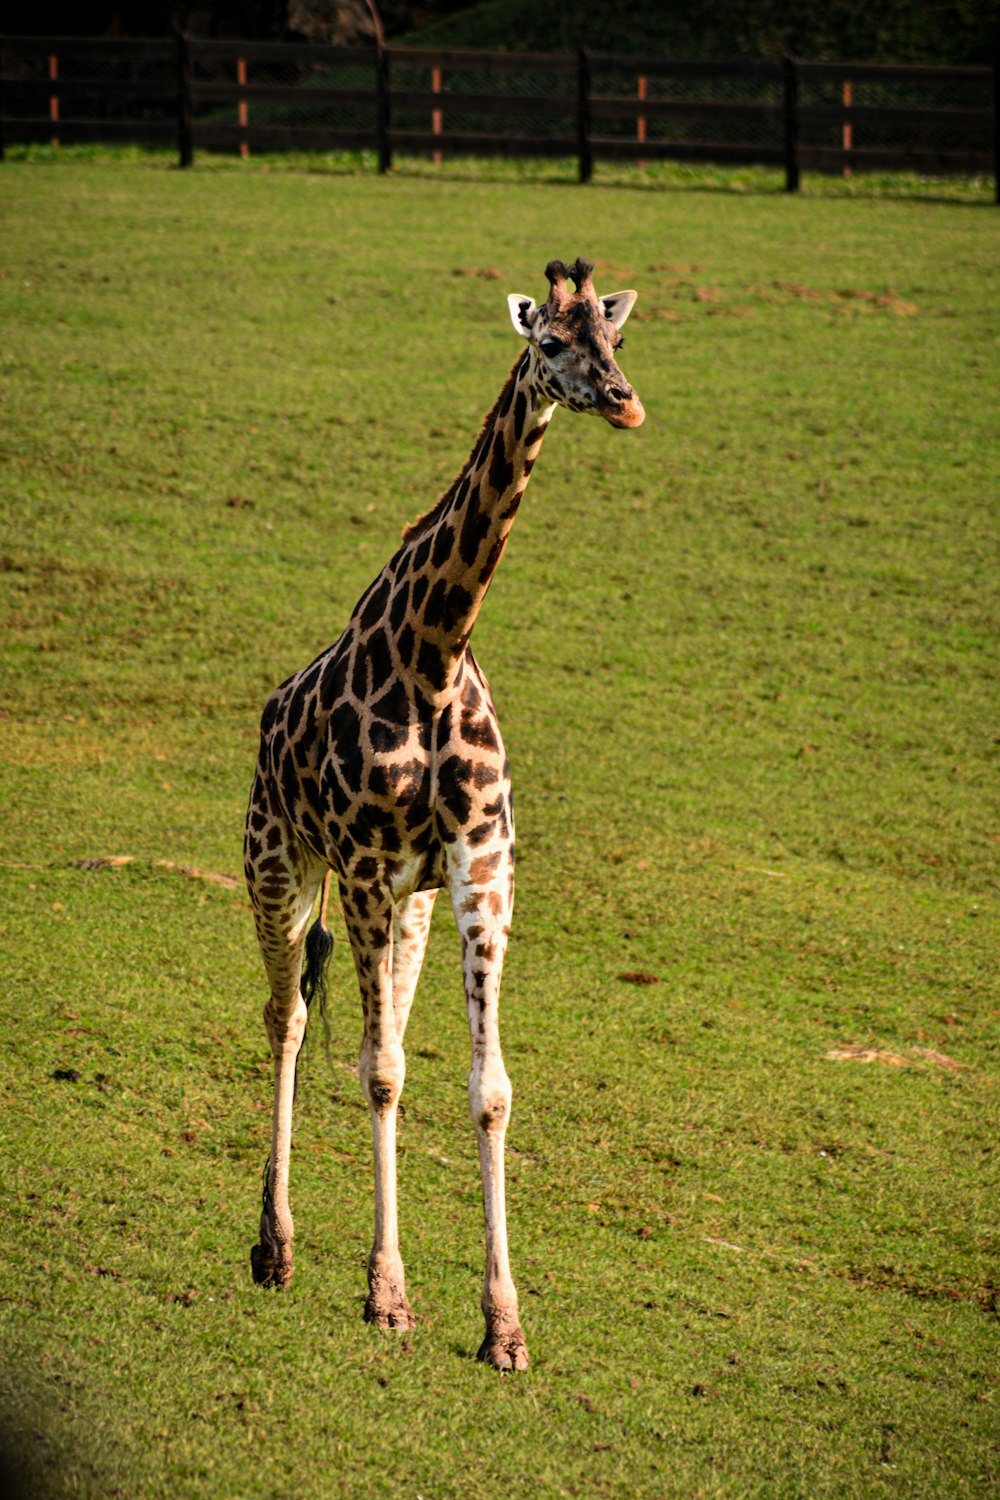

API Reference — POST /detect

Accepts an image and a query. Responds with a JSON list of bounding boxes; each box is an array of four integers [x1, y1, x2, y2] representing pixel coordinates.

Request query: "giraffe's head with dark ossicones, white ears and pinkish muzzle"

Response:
[[507, 260, 646, 428]]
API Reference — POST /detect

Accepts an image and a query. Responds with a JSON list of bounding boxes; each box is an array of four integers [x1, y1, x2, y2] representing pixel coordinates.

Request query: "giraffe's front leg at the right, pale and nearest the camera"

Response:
[[451, 849, 529, 1370]]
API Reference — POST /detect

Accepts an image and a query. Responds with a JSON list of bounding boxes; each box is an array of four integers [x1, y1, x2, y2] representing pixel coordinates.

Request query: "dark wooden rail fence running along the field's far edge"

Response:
[[0, 36, 1000, 192]]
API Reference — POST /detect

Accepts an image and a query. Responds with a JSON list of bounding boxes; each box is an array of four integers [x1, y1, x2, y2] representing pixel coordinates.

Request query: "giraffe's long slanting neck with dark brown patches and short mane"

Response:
[[394, 351, 555, 702]]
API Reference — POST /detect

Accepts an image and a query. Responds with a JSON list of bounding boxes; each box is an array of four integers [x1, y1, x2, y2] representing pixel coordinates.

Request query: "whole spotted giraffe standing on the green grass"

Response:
[[244, 260, 645, 1370]]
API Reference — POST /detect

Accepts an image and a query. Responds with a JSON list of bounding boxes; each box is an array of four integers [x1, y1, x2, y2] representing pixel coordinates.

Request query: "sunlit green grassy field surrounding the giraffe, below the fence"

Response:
[[0, 162, 1000, 1500]]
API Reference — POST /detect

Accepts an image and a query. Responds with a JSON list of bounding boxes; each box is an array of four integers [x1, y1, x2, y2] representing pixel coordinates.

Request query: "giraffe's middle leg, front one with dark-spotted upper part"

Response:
[[342, 878, 418, 1329]]
